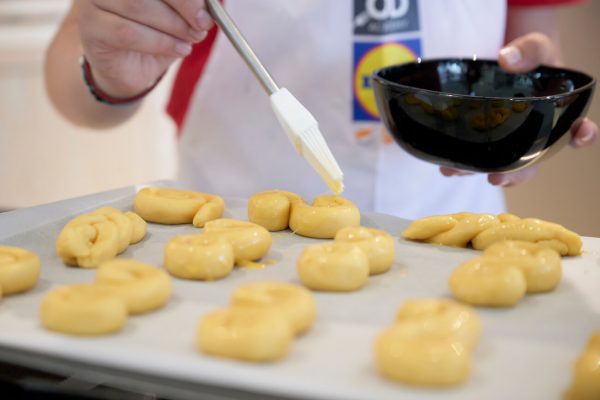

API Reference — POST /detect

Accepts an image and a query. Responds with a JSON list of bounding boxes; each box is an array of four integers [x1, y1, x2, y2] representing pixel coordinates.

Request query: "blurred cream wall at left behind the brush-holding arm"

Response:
[[0, 0, 176, 209]]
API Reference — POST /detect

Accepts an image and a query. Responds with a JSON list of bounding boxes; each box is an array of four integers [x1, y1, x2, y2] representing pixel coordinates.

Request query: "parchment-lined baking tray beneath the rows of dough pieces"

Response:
[[0, 186, 600, 400]]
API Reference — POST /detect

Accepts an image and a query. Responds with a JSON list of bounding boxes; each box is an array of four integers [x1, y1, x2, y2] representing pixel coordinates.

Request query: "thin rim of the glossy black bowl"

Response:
[[371, 57, 596, 102]]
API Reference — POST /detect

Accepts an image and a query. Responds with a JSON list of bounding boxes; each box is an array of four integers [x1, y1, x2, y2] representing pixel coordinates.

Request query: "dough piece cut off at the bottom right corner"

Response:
[[565, 331, 600, 400]]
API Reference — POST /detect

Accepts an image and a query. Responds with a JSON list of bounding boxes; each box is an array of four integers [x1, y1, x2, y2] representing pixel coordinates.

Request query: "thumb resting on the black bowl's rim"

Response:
[[498, 32, 559, 73]]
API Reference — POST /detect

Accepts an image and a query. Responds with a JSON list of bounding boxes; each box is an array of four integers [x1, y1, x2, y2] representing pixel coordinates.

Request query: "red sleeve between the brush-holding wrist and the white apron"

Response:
[[167, 27, 217, 132]]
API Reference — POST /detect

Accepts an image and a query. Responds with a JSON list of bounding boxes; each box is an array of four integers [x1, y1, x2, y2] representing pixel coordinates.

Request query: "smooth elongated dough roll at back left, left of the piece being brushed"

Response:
[[133, 187, 225, 228]]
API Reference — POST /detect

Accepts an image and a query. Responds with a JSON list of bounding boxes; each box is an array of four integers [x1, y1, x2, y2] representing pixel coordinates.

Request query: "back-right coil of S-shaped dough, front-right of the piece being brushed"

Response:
[[335, 226, 396, 275]]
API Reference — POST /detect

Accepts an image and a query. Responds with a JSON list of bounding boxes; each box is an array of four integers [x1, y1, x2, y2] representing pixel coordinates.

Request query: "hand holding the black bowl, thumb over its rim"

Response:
[[440, 33, 598, 186]]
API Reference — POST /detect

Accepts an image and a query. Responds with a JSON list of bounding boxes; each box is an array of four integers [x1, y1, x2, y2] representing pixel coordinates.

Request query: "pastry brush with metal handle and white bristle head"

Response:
[[206, 0, 344, 194]]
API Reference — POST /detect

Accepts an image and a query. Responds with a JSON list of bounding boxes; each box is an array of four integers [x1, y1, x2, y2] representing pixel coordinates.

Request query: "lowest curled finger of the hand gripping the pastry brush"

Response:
[[80, 6, 192, 57]]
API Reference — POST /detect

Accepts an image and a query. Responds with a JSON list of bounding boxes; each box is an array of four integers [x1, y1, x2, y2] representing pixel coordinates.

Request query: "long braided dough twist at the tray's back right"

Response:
[[402, 212, 582, 256]]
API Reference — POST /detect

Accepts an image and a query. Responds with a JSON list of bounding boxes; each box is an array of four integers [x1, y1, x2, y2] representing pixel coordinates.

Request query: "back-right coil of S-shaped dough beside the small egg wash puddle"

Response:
[[204, 218, 273, 263]]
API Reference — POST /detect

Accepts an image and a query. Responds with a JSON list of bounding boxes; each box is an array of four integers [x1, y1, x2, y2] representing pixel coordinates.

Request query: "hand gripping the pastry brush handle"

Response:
[[77, 0, 213, 98]]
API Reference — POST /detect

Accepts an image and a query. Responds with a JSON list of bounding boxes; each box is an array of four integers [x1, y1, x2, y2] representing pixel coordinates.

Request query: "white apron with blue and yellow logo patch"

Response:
[[179, 0, 506, 219]]
